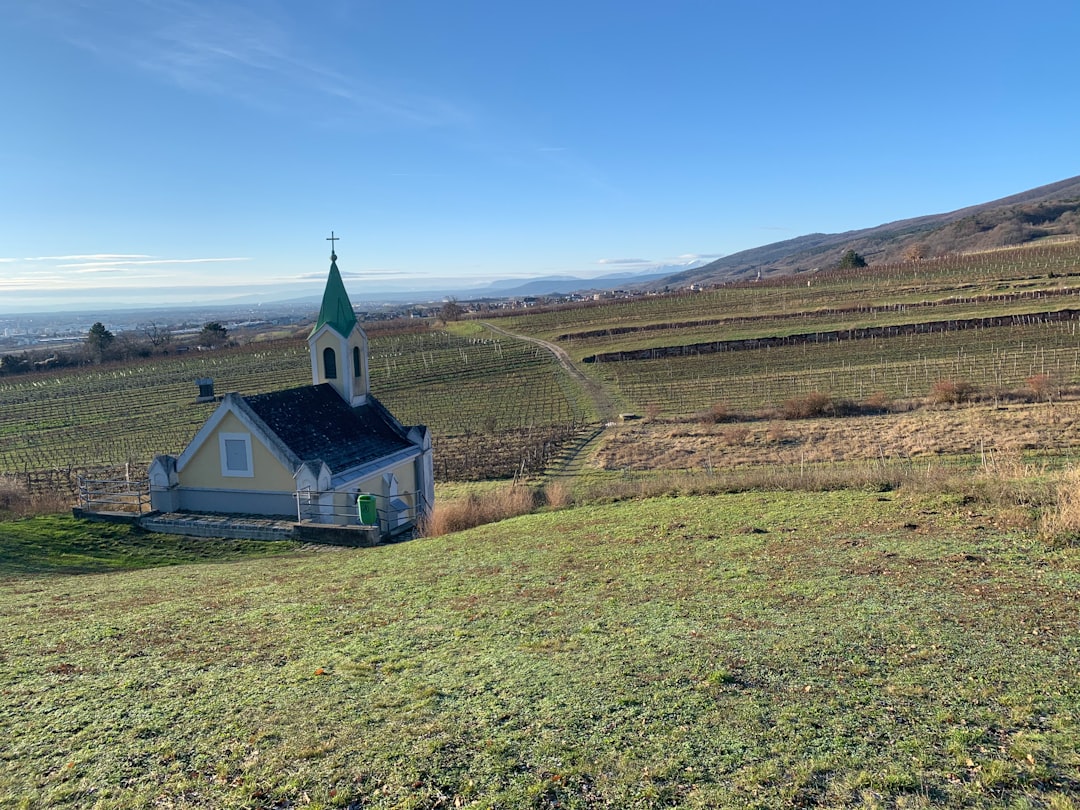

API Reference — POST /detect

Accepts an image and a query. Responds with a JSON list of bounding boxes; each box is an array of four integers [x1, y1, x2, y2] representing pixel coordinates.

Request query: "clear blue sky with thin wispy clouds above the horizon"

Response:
[[0, 0, 1080, 312]]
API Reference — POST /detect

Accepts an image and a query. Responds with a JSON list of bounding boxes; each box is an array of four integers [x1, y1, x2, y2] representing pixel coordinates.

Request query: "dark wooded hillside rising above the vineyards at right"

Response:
[[649, 176, 1080, 289]]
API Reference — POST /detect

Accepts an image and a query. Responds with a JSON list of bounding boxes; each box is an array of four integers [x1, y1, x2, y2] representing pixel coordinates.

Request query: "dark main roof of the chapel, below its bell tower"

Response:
[[243, 382, 416, 473]]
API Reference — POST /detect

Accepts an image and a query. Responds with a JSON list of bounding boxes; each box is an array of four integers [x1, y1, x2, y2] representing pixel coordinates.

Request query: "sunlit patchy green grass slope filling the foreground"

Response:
[[0, 491, 1080, 808]]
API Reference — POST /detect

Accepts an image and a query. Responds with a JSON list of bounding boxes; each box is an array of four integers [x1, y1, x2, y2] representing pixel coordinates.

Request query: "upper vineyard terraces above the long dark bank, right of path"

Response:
[[494, 242, 1080, 357]]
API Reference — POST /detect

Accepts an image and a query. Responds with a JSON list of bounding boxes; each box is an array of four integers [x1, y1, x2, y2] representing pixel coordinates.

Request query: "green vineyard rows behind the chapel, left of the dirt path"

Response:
[[0, 332, 591, 474]]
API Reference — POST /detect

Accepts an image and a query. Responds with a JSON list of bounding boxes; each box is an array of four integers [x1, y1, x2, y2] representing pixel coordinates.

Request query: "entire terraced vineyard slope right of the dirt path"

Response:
[[498, 243, 1080, 417]]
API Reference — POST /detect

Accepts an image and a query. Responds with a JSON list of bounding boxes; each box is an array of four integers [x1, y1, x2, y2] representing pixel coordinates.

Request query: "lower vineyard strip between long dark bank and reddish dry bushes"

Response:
[[590, 322, 1080, 415]]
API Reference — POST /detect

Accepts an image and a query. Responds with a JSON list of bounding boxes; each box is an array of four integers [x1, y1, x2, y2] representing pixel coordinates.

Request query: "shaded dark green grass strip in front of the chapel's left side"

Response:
[[0, 515, 298, 578]]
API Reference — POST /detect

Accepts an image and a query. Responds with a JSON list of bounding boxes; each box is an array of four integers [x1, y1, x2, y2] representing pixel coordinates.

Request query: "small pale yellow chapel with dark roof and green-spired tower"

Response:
[[149, 251, 435, 537]]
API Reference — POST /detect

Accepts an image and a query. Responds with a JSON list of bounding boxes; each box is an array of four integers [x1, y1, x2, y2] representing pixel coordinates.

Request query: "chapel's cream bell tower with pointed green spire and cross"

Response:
[[308, 231, 370, 407]]
